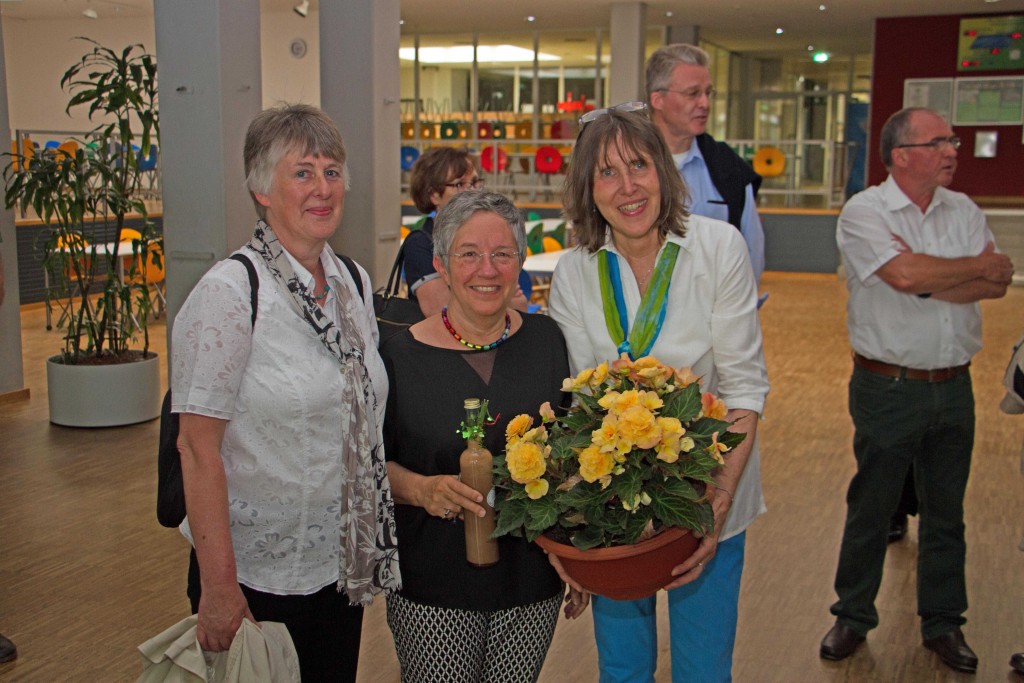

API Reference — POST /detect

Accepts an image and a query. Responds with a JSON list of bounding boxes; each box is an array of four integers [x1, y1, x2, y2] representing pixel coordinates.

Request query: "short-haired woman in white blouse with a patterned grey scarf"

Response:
[[170, 104, 400, 681]]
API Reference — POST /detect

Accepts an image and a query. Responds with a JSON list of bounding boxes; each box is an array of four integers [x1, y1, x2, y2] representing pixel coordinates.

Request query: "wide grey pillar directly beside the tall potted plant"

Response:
[[153, 0, 262, 347]]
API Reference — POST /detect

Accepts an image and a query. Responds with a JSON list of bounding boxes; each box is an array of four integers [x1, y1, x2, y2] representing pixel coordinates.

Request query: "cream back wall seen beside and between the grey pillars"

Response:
[[3, 12, 319, 142]]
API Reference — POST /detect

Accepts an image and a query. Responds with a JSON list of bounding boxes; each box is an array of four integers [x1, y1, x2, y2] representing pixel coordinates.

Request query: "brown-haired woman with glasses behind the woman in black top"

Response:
[[403, 146, 530, 316]]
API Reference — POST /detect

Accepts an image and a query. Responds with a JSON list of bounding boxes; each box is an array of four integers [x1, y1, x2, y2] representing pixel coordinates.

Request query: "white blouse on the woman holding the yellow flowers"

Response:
[[549, 215, 768, 541]]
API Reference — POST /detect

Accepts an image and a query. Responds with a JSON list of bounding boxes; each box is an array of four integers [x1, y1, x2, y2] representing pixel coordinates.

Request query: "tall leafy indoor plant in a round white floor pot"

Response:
[[4, 38, 163, 426]]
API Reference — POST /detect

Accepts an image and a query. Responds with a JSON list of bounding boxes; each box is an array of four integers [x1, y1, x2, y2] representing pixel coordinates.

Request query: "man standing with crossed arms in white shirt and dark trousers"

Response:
[[820, 109, 1014, 673]]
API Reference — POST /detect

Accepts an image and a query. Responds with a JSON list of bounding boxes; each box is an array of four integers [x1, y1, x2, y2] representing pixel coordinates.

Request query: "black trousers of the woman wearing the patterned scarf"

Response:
[[188, 550, 362, 683]]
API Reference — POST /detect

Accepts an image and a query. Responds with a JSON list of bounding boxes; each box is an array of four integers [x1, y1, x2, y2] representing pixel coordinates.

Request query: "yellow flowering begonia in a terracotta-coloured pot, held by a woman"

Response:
[[495, 355, 745, 599]]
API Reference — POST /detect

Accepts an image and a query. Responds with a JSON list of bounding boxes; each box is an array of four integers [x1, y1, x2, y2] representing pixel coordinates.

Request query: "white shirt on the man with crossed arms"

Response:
[[836, 176, 993, 370]]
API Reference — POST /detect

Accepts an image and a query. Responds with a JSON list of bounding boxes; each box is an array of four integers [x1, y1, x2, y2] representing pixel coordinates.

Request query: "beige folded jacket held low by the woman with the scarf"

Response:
[[138, 614, 299, 683]]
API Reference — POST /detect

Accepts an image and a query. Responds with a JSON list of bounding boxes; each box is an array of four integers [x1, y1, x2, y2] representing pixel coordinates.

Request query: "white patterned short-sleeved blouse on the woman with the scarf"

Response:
[[171, 248, 388, 595]]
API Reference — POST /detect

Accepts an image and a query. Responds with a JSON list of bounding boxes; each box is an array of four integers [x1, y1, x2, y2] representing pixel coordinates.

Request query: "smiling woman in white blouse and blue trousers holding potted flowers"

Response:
[[550, 102, 768, 682]]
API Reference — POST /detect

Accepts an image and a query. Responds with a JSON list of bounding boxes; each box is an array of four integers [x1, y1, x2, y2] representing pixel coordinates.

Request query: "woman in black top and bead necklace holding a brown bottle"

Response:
[[381, 191, 586, 683]]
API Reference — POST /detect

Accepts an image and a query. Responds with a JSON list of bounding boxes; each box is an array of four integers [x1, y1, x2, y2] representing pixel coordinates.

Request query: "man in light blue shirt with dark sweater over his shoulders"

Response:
[[647, 43, 765, 284]]
